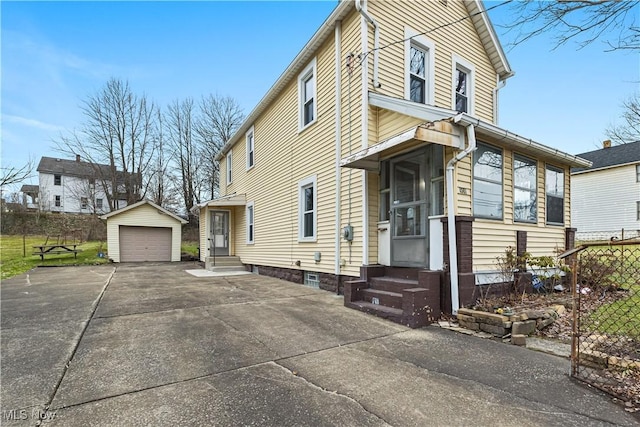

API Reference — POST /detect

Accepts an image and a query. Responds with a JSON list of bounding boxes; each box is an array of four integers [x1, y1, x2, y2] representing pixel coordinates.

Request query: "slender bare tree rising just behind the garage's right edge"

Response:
[[165, 98, 202, 216]]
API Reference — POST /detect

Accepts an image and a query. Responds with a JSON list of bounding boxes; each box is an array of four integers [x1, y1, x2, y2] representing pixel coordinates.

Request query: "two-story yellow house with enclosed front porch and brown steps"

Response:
[[199, 0, 589, 325]]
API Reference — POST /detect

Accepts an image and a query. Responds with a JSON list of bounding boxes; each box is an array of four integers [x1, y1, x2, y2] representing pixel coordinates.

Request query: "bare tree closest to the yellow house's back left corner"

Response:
[[196, 94, 244, 199]]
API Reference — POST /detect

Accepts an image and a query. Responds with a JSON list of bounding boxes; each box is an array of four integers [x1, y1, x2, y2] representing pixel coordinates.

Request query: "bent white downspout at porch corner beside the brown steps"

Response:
[[446, 115, 476, 314]]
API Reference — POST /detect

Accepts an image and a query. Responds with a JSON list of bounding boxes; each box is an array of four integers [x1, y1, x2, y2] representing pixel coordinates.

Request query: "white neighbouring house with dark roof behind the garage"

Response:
[[37, 155, 127, 214]]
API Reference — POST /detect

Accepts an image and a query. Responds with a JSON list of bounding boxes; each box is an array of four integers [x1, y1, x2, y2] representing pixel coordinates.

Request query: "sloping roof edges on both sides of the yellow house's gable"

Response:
[[215, 0, 514, 161]]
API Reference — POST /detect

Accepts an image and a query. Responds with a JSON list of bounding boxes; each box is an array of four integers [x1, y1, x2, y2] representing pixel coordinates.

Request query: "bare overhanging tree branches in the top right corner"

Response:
[[504, 0, 640, 50]]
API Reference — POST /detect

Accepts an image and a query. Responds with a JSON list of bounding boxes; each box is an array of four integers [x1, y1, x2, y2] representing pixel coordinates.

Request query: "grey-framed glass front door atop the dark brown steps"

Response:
[[390, 150, 429, 267]]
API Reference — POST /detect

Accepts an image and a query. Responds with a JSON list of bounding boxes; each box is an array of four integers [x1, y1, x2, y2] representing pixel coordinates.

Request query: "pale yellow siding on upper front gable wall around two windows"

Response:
[[367, 1, 497, 123]]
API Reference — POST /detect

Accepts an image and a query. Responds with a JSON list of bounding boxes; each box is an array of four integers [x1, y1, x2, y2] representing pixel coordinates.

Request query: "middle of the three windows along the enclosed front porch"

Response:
[[513, 155, 538, 222]]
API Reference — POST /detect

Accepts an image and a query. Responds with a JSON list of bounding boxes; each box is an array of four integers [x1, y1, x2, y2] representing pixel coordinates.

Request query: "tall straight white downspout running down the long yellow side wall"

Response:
[[334, 21, 342, 294]]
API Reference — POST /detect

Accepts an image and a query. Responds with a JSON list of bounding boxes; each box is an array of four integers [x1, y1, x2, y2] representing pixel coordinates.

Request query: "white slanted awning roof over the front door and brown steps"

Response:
[[340, 120, 464, 171]]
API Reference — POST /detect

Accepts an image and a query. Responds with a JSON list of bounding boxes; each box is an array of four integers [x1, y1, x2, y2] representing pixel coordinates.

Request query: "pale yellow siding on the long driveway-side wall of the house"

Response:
[[220, 14, 362, 276]]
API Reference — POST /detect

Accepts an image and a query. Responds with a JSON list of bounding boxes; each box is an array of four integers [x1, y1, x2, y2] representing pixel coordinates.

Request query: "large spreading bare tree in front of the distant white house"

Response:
[[56, 78, 155, 209]]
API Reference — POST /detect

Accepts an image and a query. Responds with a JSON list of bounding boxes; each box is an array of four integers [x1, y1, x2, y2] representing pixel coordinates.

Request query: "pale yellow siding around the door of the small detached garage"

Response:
[[107, 204, 182, 262]]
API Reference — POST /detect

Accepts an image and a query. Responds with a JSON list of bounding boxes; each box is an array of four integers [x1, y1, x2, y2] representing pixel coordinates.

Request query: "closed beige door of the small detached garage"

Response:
[[120, 225, 171, 262]]
